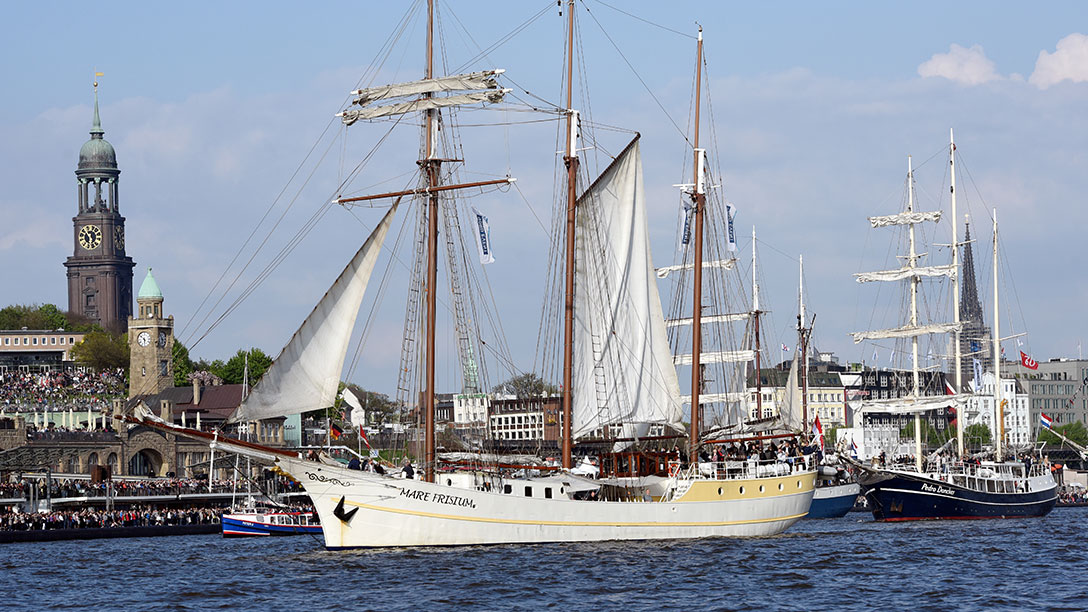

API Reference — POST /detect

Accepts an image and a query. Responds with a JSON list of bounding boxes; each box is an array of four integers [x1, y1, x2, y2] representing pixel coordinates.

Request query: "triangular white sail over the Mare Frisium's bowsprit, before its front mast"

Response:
[[226, 204, 397, 423]]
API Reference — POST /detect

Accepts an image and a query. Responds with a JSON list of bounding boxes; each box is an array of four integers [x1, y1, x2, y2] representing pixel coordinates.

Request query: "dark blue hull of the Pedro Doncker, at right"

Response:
[[862, 470, 1058, 521]]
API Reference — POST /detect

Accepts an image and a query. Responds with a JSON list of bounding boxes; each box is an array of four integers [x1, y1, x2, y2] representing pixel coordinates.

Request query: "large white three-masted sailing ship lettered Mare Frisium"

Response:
[[127, 0, 815, 542]]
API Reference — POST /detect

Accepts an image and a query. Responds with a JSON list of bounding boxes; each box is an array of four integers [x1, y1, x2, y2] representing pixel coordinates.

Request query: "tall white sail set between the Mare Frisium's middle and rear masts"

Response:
[[571, 138, 682, 438]]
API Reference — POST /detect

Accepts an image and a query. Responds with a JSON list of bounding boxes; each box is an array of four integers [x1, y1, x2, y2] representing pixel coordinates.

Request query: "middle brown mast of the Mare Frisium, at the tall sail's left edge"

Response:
[[562, 0, 578, 469]]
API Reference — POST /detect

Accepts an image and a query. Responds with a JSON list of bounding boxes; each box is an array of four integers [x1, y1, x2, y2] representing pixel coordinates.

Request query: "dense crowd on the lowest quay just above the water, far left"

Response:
[[0, 506, 223, 531]]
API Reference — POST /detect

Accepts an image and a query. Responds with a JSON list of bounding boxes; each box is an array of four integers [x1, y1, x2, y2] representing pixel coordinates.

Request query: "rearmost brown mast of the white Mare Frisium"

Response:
[[689, 26, 706, 463]]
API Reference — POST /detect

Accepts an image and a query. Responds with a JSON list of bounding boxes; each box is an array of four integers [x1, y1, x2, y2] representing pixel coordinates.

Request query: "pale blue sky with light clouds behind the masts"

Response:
[[0, 0, 1088, 394]]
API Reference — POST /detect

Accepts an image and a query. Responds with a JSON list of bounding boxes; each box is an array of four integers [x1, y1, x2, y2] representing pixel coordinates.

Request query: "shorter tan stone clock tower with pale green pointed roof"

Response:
[[128, 268, 174, 397]]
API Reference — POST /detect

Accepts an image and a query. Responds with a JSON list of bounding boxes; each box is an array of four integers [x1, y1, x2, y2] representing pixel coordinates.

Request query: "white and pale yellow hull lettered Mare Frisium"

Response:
[[277, 457, 815, 549]]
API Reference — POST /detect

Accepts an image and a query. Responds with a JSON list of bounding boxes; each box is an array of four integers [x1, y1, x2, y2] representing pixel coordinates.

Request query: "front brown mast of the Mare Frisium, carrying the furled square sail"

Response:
[[422, 0, 441, 482]]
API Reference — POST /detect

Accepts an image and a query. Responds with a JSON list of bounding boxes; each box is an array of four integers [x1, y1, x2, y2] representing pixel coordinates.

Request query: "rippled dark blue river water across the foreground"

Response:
[[0, 507, 1088, 612]]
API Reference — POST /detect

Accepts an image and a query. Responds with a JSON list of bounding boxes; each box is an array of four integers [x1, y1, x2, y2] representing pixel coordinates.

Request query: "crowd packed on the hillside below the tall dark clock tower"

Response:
[[0, 369, 125, 412]]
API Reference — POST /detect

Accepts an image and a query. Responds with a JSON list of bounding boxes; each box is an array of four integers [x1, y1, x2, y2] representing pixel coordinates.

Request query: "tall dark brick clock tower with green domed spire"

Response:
[[64, 83, 136, 332]]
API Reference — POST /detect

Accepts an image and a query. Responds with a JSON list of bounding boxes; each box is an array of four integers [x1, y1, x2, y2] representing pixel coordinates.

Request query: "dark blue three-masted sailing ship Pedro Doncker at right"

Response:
[[846, 132, 1058, 521]]
